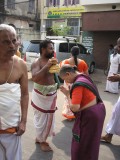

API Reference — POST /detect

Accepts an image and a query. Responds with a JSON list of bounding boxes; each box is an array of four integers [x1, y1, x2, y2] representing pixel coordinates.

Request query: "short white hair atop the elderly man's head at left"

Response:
[[0, 24, 16, 34]]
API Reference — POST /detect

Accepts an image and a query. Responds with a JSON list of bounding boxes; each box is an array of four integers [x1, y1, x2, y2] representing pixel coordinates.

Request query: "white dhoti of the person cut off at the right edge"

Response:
[[106, 97, 120, 136]]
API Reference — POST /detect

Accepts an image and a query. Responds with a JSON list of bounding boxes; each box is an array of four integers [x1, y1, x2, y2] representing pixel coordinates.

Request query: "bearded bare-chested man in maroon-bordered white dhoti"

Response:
[[32, 40, 57, 151]]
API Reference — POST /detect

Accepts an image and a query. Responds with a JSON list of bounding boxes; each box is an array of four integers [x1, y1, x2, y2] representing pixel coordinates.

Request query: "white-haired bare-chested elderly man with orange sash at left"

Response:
[[0, 24, 28, 160]]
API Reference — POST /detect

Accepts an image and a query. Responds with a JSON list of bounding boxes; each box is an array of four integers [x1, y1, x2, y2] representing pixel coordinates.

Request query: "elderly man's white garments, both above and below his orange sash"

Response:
[[0, 83, 22, 160]]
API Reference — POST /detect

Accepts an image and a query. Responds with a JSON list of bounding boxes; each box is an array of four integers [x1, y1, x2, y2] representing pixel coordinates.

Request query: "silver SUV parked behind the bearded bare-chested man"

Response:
[[26, 36, 95, 73]]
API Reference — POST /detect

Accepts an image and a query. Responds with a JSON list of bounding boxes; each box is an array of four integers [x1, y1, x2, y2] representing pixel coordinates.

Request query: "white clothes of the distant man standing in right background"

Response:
[[106, 53, 120, 93]]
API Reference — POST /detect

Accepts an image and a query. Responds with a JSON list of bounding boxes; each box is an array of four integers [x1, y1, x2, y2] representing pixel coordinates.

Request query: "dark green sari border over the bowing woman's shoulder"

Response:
[[70, 75, 102, 102]]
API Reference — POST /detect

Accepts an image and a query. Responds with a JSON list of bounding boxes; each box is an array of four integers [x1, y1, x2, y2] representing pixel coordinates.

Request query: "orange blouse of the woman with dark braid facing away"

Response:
[[60, 59, 88, 72]]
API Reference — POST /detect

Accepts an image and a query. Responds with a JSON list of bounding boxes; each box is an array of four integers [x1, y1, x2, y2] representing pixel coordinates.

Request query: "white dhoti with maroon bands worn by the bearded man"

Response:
[[31, 85, 57, 142]]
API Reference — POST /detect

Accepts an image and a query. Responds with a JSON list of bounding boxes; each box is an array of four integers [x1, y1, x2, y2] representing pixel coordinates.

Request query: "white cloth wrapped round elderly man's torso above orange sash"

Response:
[[0, 83, 21, 130]]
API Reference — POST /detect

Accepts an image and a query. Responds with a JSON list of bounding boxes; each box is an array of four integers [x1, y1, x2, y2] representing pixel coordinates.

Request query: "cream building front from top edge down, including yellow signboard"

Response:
[[41, 0, 84, 40]]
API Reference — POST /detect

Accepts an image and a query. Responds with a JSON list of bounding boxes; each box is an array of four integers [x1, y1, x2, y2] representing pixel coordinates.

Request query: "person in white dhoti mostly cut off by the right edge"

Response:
[[101, 38, 120, 143]]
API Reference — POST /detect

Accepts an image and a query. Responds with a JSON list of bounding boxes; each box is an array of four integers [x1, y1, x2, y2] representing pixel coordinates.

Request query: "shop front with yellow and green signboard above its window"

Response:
[[46, 6, 84, 37]]
